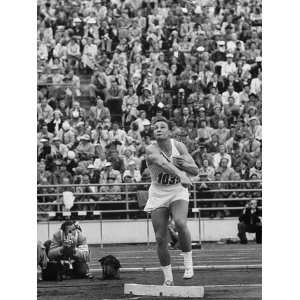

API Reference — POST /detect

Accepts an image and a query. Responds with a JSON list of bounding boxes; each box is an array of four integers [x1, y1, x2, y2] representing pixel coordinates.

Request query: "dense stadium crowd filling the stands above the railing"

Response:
[[37, 0, 262, 213]]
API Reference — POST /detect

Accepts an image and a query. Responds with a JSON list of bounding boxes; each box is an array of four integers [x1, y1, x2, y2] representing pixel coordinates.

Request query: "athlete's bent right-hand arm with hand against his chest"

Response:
[[173, 141, 199, 176]]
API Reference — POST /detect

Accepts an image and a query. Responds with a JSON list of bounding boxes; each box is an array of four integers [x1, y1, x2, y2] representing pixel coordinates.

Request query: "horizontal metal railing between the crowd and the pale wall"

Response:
[[37, 180, 262, 220]]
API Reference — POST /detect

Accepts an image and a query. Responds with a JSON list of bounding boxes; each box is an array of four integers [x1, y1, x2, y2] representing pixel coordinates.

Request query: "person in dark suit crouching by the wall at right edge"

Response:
[[238, 200, 262, 244]]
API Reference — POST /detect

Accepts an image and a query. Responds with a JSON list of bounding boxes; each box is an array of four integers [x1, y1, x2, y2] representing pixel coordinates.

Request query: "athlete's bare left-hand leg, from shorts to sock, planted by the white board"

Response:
[[151, 207, 170, 266]]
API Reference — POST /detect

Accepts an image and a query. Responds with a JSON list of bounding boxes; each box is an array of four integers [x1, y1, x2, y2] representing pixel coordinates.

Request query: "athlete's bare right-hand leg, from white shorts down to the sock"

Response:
[[170, 200, 192, 252]]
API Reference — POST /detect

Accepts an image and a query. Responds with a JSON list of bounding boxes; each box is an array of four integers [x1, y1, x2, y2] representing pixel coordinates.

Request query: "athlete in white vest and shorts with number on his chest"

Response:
[[144, 117, 198, 285]]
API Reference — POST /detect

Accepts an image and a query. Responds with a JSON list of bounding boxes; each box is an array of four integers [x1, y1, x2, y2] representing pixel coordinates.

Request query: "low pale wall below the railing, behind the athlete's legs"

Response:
[[37, 218, 238, 244]]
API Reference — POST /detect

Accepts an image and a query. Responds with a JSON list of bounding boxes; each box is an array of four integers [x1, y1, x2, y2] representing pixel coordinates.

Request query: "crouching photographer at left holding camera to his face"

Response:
[[48, 221, 90, 278]]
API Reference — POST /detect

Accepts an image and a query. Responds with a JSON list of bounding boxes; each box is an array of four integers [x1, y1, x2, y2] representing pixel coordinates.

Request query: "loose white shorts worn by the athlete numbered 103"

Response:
[[144, 183, 190, 212]]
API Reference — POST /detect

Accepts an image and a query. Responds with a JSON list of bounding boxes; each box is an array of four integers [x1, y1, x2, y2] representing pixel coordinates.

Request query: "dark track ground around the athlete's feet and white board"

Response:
[[38, 243, 261, 300]]
